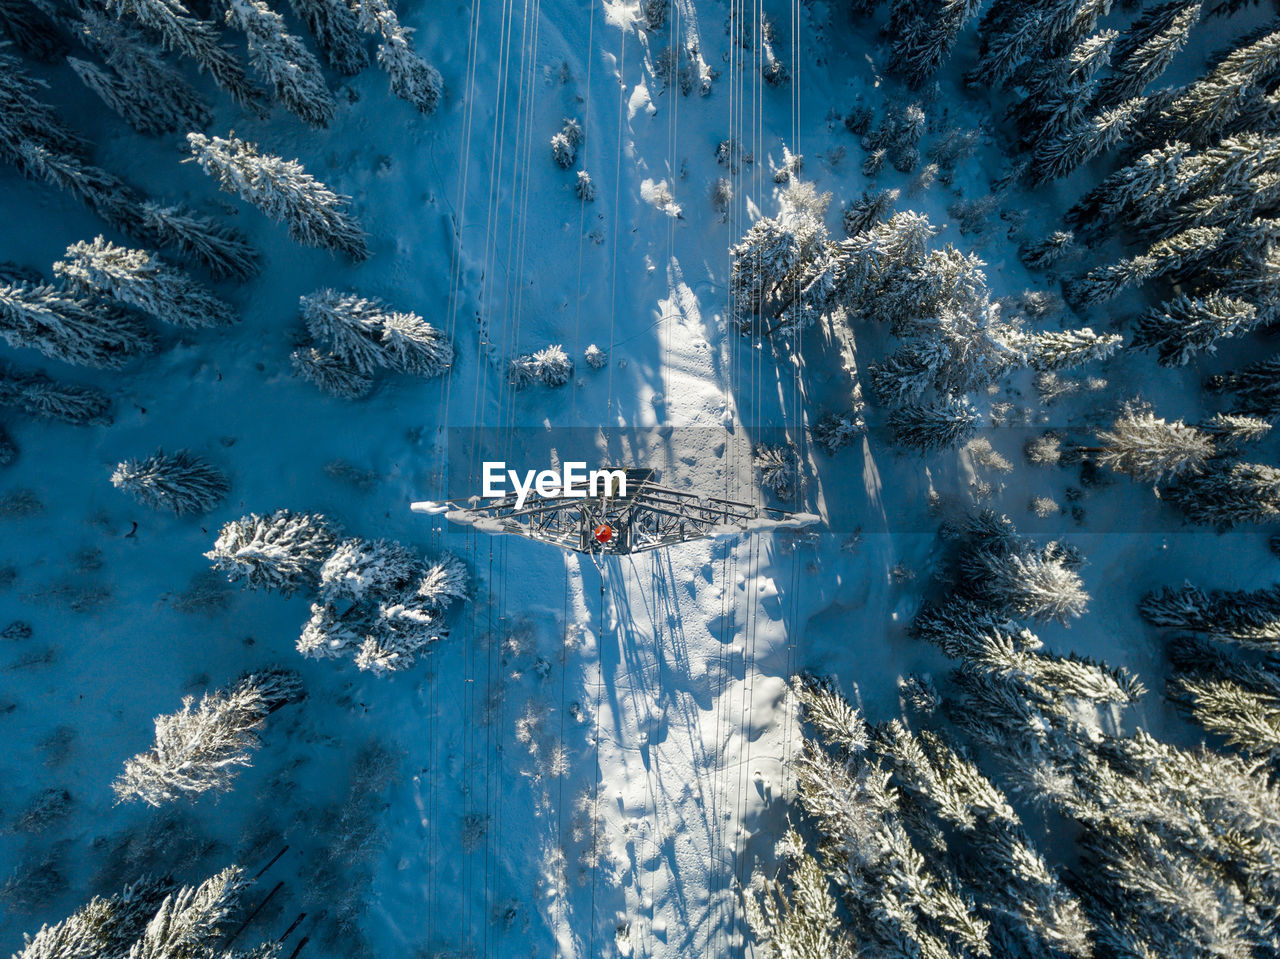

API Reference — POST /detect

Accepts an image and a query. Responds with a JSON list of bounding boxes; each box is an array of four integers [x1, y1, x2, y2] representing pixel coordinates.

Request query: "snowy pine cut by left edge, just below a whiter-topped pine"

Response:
[[0, 283, 155, 369]]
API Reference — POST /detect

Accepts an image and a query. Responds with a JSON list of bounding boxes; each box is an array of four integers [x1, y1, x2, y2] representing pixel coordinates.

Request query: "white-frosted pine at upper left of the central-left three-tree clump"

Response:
[[205, 510, 337, 595]]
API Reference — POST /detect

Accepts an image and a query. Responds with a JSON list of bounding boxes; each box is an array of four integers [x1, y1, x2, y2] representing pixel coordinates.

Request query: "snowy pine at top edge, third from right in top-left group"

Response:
[[227, 0, 334, 127]]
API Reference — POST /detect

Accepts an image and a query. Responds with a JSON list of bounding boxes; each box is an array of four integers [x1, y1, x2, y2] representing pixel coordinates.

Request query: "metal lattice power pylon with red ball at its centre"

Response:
[[412, 467, 818, 554]]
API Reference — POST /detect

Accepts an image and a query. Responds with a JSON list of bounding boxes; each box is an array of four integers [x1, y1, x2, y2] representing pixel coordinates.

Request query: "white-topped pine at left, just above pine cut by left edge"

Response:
[[54, 237, 239, 328]]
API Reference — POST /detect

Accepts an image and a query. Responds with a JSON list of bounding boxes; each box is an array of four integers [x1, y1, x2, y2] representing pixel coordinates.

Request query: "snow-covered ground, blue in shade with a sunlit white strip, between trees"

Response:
[[0, 0, 1275, 958]]
